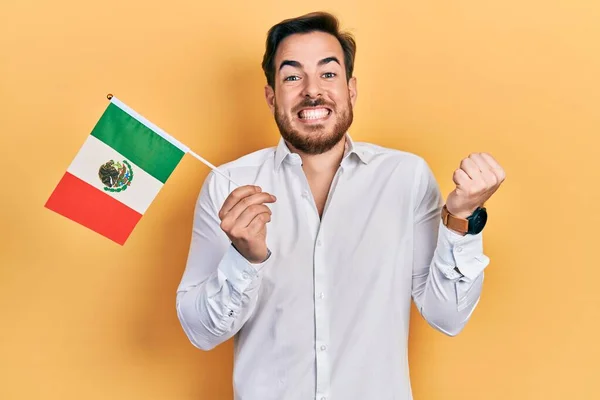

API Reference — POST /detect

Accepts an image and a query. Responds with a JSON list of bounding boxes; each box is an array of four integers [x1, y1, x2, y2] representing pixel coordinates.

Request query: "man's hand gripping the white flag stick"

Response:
[[219, 185, 277, 263]]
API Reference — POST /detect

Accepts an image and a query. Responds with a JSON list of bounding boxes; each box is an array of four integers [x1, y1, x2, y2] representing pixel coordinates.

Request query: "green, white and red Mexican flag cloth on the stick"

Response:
[[45, 97, 189, 245]]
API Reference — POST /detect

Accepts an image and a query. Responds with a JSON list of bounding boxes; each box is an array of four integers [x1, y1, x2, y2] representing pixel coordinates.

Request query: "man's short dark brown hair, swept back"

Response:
[[262, 12, 356, 88]]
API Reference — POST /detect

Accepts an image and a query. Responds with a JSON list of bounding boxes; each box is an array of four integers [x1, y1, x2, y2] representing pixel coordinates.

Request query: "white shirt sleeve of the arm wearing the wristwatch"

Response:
[[412, 160, 489, 336]]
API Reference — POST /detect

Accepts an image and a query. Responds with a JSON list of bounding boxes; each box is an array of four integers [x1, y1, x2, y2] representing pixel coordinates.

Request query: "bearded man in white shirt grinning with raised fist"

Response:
[[177, 13, 504, 400]]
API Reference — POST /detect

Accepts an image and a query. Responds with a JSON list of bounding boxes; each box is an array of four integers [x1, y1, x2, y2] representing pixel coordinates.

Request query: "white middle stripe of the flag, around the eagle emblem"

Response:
[[67, 135, 163, 214]]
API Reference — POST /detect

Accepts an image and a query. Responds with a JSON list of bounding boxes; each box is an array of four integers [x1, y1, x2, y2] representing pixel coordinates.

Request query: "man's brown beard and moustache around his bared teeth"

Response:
[[275, 98, 354, 155]]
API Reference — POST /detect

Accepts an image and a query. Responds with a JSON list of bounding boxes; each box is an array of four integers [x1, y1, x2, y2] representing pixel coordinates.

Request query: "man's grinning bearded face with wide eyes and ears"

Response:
[[265, 32, 356, 154]]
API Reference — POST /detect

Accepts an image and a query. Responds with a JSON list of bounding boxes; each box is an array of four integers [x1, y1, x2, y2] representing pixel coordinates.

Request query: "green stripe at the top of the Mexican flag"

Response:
[[92, 103, 185, 183]]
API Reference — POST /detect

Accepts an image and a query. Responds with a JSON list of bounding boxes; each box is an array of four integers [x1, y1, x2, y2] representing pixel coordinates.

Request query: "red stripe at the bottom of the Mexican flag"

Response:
[[45, 172, 142, 245]]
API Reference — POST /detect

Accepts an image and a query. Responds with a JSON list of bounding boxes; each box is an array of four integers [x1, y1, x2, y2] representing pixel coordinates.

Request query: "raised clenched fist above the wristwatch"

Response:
[[446, 153, 506, 218]]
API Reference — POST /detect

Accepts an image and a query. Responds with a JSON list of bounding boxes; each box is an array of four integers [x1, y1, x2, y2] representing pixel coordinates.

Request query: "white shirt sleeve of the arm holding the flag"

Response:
[[176, 172, 271, 350]]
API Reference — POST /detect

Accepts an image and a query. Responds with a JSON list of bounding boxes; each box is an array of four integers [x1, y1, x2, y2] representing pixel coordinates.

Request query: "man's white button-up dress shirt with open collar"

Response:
[[176, 135, 489, 400]]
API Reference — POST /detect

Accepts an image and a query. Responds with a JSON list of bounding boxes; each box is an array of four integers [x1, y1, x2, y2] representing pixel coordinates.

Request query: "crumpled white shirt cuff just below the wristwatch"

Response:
[[437, 222, 490, 280]]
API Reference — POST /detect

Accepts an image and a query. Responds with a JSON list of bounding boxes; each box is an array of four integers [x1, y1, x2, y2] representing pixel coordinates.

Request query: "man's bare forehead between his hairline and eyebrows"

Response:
[[275, 32, 344, 70]]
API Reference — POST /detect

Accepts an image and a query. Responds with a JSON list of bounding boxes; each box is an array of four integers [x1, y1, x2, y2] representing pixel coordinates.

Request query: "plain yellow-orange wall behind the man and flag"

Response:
[[0, 0, 600, 400]]
